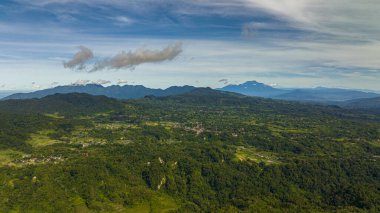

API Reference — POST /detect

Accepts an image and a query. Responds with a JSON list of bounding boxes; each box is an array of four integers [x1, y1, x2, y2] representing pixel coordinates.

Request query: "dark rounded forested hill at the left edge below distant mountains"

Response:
[[0, 93, 123, 115]]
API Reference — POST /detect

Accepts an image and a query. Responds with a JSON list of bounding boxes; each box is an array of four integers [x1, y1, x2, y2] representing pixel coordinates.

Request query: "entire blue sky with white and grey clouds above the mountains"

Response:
[[0, 0, 380, 91]]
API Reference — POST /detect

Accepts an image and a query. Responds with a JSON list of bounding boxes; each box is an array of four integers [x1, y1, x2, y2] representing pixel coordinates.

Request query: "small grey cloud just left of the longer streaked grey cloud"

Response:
[[63, 46, 94, 70]]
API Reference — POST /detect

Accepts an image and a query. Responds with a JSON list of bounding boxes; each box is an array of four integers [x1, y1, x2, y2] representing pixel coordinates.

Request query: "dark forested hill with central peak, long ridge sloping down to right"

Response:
[[145, 88, 374, 120]]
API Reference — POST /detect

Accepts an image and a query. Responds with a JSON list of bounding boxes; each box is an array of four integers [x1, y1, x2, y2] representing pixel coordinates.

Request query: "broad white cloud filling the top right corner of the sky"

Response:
[[242, 0, 380, 39]]
